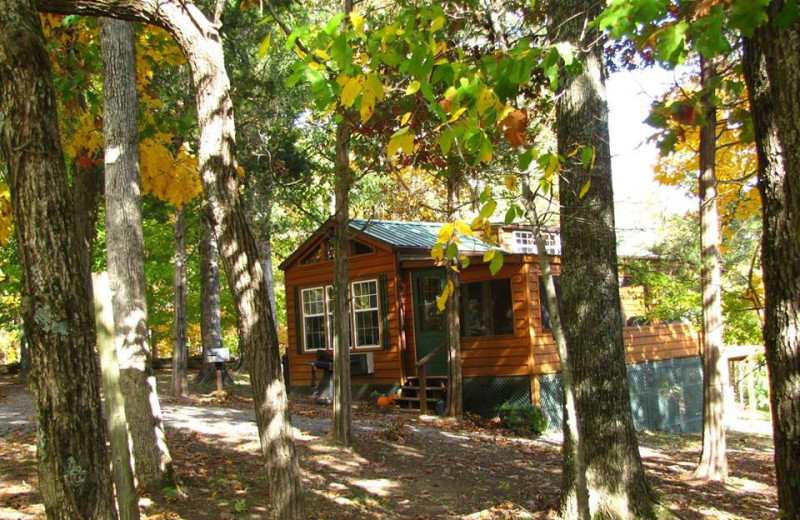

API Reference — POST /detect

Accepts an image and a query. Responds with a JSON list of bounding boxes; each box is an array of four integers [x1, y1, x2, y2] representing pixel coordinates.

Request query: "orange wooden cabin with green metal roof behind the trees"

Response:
[[281, 219, 702, 431]]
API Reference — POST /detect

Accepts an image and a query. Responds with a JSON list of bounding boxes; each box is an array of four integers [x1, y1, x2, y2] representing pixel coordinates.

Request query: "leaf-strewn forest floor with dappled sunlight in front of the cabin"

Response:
[[0, 373, 777, 520]]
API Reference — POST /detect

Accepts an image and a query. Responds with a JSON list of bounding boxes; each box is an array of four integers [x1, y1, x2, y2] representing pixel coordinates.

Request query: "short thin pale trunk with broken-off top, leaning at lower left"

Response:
[[92, 272, 139, 520]]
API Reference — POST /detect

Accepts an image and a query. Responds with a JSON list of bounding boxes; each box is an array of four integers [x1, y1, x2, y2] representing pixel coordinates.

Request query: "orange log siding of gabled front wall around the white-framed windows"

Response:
[[285, 237, 402, 387]]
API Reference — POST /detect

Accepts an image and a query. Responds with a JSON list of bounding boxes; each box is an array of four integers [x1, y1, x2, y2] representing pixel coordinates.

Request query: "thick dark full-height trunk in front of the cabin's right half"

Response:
[[550, 0, 655, 518]]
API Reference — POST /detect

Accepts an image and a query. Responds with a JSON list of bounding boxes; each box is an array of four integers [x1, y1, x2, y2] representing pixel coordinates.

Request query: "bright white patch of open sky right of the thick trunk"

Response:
[[606, 68, 697, 252]]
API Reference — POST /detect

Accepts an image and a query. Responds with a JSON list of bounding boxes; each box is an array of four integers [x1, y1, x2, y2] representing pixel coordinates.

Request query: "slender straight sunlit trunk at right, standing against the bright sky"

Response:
[[694, 57, 728, 482]]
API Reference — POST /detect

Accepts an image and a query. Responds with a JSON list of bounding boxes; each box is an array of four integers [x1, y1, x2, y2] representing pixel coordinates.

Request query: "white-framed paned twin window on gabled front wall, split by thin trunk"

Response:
[[301, 280, 381, 351]]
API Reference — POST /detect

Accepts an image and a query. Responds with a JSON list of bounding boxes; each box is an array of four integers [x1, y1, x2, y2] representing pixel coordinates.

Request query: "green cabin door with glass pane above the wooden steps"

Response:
[[411, 268, 447, 376]]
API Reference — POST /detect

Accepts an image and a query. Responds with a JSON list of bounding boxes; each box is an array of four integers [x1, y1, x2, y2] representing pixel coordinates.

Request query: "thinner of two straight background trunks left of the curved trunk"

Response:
[[172, 209, 189, 397]]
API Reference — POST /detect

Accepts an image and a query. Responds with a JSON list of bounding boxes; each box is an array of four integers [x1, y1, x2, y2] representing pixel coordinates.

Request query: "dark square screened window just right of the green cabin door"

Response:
[[461, 279, 514, 338]]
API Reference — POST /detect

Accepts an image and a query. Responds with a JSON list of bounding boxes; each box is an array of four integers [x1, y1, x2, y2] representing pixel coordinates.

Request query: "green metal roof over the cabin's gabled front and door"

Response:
[[350, 219, 493, 253]]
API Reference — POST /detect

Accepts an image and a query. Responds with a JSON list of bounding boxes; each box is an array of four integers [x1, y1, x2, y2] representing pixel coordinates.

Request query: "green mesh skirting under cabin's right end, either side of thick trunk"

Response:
[[539, 356, 703, 433]]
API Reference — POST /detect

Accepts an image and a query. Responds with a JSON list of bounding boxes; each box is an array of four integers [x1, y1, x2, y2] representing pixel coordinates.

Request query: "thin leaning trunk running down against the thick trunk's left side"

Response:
[[523, 191, 591, 520]]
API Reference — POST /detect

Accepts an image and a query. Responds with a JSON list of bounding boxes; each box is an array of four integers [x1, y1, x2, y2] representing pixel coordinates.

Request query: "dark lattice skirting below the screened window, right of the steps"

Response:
[[463, 376, 531, 418]]
